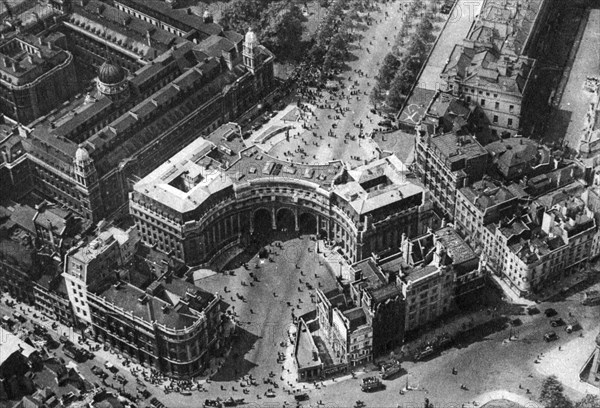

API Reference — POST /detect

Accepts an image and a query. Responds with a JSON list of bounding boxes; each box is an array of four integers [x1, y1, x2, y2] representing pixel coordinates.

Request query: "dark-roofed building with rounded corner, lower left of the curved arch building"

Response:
[[88, 271, 222, 379]]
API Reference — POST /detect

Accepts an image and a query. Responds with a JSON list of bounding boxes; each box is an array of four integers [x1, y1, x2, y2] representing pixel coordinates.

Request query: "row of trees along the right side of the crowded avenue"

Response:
[[371, 0, 435, 109]]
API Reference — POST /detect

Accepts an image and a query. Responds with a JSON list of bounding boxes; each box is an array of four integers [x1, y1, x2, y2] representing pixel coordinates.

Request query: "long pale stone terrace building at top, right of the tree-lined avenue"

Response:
[[441, 0, 550, 135]]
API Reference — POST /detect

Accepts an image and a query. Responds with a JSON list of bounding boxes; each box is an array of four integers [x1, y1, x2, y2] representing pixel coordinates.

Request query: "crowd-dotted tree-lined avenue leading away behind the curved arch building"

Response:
[[269, 0, 427, 165]]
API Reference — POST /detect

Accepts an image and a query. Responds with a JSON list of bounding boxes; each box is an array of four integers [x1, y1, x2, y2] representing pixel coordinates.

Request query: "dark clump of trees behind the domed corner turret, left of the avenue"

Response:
[[220, 0, 306, 60]]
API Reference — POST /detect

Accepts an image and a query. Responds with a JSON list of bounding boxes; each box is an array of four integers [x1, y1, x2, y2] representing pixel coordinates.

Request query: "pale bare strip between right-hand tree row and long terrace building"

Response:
[[417, 0, 483, 91]]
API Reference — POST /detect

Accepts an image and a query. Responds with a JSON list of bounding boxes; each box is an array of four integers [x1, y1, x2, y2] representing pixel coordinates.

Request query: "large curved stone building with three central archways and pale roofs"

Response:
[[130, 124, 434, 264]]
